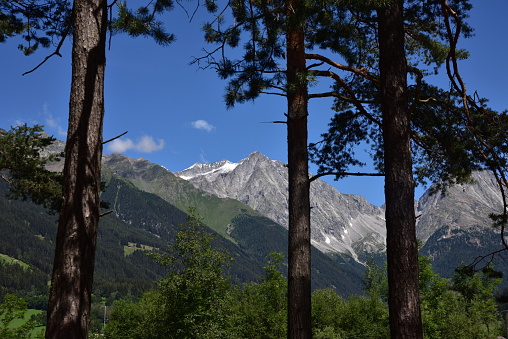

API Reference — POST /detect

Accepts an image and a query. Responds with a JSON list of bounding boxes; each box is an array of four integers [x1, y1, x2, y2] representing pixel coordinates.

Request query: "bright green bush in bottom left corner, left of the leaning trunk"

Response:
[[0, 294, 43, 339]]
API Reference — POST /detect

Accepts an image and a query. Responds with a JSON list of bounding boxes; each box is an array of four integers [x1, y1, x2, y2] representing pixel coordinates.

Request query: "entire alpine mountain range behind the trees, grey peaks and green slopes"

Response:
[[4, 131, 508, 296]]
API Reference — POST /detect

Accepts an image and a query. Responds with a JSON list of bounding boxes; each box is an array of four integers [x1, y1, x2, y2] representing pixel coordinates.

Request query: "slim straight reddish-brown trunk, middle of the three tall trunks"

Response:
[[286, 0, 312, 339]]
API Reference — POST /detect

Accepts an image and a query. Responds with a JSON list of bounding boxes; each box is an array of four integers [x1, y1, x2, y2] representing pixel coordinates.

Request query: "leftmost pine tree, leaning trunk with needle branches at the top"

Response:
[[0, 0, 178, 338]]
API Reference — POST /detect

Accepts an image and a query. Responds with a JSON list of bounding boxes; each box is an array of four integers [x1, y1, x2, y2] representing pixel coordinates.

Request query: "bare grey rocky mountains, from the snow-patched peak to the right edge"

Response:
[[175, 152, 508, 277]]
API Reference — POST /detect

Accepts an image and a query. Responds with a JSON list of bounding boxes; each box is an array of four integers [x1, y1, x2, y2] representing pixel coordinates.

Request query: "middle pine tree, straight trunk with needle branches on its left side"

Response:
[[197, 0, 312, 338]]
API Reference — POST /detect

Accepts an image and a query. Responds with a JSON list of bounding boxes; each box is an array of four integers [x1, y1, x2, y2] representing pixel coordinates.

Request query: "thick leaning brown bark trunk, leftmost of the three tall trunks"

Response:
[[46, 0, 107, 339]]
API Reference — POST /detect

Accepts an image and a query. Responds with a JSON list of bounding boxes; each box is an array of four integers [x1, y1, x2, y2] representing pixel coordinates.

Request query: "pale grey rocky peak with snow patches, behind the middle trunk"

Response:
[[174, 152, 386, 258]]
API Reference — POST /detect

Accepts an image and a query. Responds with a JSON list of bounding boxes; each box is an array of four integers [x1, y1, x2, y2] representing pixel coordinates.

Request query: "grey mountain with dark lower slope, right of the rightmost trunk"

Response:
[[417, 171, 508, 286]]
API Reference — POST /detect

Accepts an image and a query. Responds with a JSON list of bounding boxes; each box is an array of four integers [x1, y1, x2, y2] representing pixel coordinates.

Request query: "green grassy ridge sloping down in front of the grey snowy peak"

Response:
[[104, 154, 364, 295]]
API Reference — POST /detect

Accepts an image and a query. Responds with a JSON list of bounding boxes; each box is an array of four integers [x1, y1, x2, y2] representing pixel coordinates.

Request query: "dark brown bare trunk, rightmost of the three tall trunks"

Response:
[[378, 0, 423, 338]]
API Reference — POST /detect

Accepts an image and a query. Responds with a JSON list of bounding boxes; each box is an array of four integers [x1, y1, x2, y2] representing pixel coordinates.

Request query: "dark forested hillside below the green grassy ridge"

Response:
[[0, 168, 363, 308]]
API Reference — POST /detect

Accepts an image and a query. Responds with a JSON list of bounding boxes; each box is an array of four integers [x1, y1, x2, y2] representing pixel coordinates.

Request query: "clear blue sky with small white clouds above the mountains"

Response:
[[0, 0, 508, 205]]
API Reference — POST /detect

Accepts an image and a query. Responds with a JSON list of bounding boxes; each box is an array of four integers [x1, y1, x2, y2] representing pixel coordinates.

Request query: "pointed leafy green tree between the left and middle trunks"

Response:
[[106, 209, 236, 338]]
